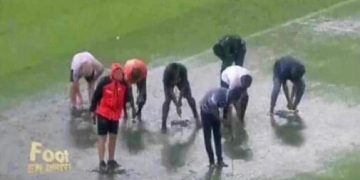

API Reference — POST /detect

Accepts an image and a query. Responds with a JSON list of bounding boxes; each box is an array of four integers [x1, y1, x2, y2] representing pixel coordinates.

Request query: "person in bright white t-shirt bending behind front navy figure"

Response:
[[221, 65, 252, 125]]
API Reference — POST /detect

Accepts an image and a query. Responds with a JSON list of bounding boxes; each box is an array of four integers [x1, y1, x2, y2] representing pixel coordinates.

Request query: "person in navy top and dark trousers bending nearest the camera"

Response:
[[200, 88, 231, 167]]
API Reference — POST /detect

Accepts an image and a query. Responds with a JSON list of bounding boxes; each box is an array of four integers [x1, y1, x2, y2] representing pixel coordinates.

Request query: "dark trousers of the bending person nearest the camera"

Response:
[[201, 111, 223, 164]]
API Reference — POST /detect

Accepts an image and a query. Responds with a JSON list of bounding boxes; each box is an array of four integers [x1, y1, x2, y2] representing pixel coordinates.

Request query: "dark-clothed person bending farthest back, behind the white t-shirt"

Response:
[[213, 35, 246, 73]]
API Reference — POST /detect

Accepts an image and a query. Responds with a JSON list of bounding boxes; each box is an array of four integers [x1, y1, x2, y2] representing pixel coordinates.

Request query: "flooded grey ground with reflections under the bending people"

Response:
[[0, 51, 360, 180]]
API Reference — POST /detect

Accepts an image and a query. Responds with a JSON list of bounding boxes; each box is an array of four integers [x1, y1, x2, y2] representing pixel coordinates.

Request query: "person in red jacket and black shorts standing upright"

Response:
[[90, 63, 129, 171]]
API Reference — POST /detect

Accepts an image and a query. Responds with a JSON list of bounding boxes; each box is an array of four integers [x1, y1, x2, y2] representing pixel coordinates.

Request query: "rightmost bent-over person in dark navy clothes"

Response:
[[270, 56, 305, 115]]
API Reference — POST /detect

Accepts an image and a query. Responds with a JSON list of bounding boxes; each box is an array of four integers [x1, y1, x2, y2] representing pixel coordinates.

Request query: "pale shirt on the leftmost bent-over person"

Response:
[[71, 51, 104, 81]]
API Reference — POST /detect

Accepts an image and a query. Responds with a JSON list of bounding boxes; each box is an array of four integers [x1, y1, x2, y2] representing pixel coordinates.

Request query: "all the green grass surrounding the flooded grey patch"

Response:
[[0, 0, 360, 180]]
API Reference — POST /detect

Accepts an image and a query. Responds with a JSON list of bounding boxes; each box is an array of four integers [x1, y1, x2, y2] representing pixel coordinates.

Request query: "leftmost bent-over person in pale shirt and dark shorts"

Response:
[[70, 51, 104, 109]]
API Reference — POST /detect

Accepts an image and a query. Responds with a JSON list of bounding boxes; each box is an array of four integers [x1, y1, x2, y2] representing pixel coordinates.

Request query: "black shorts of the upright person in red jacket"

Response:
[[97, 115, 119, 136]]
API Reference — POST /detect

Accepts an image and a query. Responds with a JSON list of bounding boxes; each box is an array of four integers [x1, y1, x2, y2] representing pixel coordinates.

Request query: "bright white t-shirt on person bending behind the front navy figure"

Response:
[[221, 65, 250, 89]]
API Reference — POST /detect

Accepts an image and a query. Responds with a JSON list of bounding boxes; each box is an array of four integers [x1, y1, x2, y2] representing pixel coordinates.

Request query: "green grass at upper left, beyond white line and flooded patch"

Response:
[[0, 0, 340, 107]]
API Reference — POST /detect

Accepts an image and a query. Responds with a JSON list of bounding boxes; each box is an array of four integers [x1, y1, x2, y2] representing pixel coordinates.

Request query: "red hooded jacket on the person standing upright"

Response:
[[90, 63, 128, 121]]
